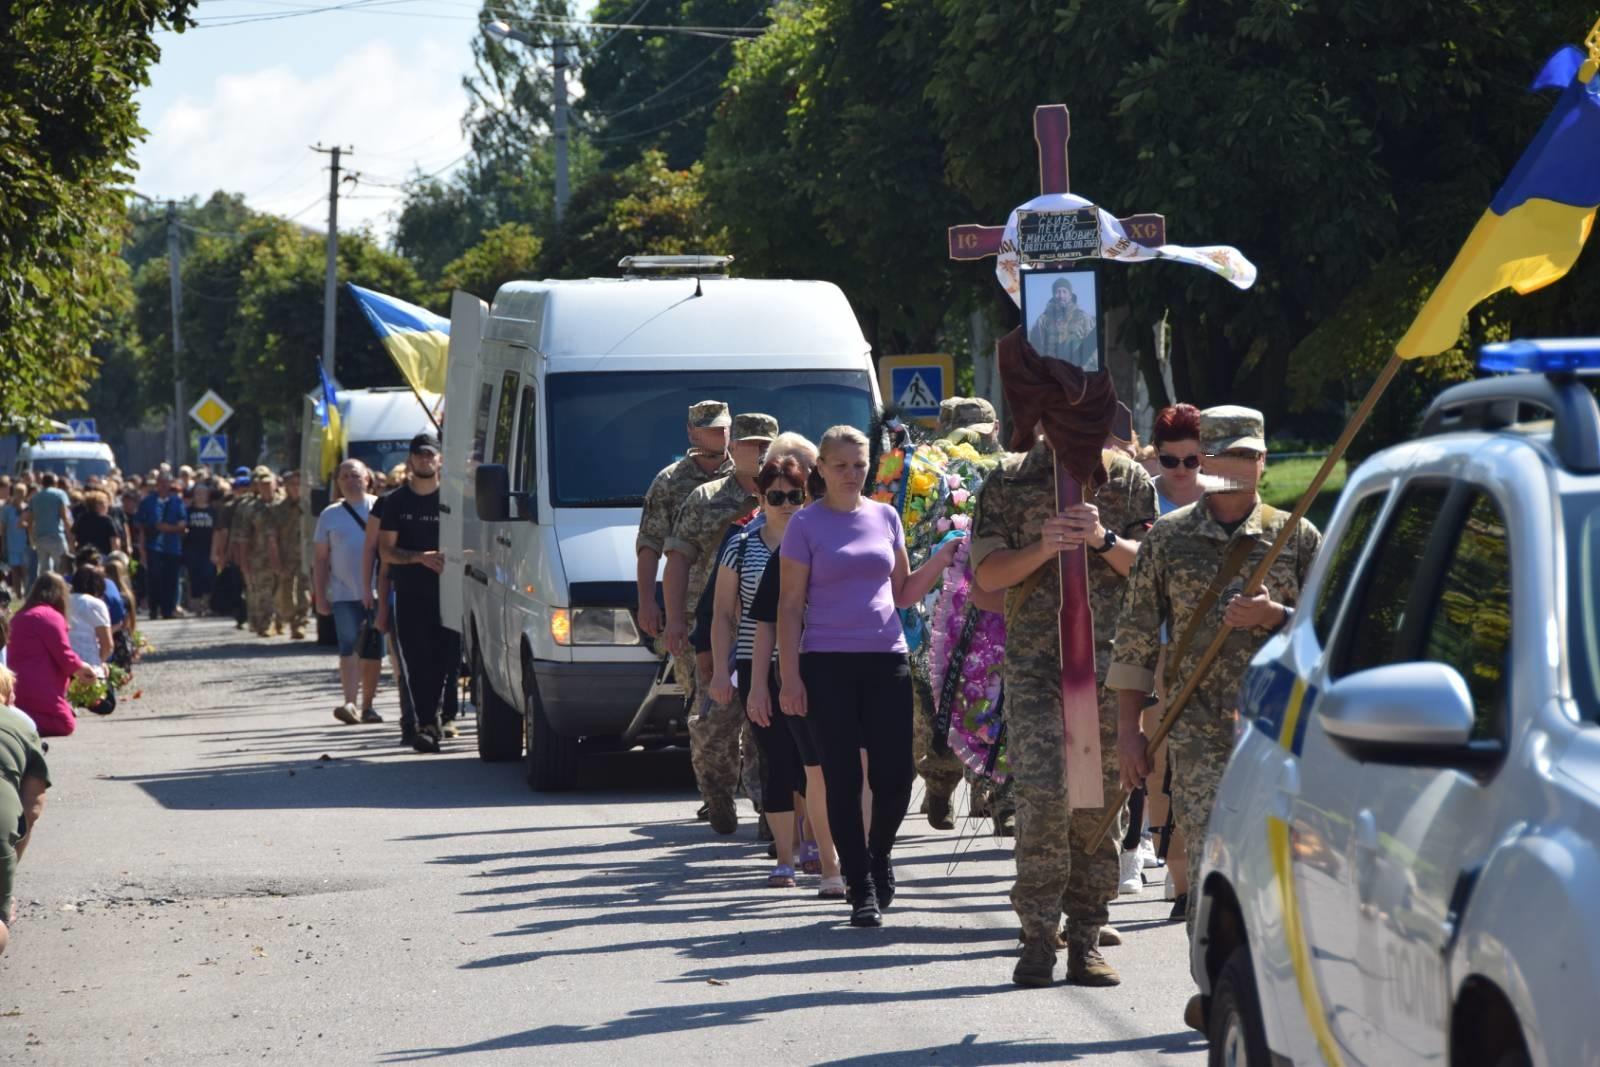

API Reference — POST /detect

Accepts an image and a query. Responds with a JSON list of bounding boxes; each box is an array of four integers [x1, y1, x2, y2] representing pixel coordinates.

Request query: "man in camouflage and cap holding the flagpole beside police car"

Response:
[[1106, 405, 1322, 1027]]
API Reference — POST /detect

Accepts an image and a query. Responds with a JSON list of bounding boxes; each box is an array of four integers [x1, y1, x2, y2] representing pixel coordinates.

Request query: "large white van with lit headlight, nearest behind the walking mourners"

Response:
[[440, 258, 878, 790]]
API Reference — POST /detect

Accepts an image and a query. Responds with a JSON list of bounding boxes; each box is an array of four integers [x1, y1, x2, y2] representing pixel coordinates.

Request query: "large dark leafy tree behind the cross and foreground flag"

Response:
[[930, 0, 1592, 435]]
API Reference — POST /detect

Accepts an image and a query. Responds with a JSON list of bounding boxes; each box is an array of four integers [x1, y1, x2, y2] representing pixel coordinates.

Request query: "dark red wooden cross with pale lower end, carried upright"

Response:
[[949, 104, 1166, 808]]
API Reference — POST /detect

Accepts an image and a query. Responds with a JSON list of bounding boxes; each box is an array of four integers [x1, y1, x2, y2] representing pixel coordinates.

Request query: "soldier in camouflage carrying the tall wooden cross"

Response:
[[971, 437, 1157, 987]]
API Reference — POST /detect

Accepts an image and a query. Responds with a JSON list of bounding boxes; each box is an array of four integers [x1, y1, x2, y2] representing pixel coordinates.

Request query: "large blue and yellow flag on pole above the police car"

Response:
[[1395, 41, 1600, 358]]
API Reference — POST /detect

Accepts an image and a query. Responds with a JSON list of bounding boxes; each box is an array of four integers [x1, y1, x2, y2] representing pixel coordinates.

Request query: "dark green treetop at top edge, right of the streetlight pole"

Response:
[[578, 0, 770, 170]]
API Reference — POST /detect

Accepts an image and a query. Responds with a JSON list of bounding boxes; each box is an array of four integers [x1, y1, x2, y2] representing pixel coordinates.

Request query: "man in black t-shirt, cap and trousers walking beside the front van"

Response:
[[378, 434, 461, 752]]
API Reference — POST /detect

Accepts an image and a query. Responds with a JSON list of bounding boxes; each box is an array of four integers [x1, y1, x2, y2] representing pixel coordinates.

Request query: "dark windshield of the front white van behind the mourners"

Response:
[[546, 370, 872, 507]]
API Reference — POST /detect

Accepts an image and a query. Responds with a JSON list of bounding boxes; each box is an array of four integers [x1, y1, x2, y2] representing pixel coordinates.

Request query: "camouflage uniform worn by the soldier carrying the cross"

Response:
[[971, 442, 1157, 949]]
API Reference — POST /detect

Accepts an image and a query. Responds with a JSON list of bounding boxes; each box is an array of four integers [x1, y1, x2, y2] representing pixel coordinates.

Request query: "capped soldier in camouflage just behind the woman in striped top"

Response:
[[662, 413, 778, 833]]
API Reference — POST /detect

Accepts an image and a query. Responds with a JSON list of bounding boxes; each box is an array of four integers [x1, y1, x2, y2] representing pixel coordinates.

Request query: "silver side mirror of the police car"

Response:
[[1317, 662, 1475, 763]]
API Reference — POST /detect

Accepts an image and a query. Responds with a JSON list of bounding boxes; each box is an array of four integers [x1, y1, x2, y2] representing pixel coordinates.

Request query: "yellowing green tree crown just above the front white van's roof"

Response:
[[541, 149, 728, 278]]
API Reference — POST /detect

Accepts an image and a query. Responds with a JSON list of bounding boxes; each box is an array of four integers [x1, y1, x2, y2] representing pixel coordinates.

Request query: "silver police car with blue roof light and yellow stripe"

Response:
[[1190, 339, 1600, 1067]]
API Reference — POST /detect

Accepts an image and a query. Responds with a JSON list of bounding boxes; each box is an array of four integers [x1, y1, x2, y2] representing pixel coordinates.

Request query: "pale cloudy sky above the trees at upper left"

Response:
[[134, 0, 592, 238]]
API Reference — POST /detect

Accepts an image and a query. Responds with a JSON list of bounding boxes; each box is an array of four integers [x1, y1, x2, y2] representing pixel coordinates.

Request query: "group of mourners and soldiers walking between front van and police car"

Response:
[[635, 397, 1320, 1025]]
